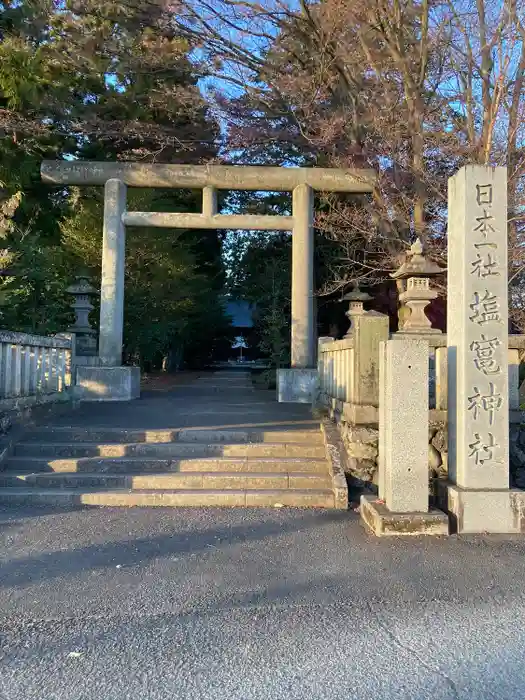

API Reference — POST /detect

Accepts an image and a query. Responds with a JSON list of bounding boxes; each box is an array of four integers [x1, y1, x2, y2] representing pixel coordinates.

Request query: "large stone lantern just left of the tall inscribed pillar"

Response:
[[390, 238, 443, 334]]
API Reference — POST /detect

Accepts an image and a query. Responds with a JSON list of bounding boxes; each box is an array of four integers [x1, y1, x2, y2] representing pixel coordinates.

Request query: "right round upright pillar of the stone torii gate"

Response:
[[291, 185, 316, 368]]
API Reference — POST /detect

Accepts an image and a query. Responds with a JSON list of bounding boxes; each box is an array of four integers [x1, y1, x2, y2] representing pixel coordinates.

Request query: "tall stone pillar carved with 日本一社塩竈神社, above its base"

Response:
[[447, 165, 509, 489]]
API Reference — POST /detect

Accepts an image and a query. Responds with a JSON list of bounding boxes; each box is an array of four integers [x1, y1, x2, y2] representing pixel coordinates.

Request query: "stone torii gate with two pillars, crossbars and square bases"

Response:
[[41, 161, 376, 402]]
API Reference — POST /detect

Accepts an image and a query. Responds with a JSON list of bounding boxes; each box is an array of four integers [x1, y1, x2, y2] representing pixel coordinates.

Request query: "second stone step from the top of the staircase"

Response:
[[14, 442, 326, 459]]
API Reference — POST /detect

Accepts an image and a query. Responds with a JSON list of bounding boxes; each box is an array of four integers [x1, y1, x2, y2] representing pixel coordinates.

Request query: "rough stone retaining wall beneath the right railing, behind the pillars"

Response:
[[336, 416, 525, 489]]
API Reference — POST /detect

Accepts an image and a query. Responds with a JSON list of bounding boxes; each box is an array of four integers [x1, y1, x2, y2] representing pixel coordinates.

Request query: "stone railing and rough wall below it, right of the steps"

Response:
[[317, 312, 525, 488]]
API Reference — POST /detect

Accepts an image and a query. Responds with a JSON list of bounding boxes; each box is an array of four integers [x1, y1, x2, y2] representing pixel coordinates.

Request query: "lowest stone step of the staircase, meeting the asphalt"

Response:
[[0, 487, 335, 508]]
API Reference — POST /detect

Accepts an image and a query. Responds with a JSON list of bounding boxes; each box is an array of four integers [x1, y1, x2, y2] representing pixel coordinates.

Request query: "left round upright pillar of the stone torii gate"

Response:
[[99, 180, 126, 367]]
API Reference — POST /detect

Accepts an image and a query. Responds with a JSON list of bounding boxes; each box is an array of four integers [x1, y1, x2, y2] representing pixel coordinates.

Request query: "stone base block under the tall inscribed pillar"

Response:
[[437, 481, 525, 535]]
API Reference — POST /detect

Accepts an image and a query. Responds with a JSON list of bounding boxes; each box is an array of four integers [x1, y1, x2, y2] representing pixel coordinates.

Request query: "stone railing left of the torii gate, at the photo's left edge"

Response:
[[0, 331, 73, 409]]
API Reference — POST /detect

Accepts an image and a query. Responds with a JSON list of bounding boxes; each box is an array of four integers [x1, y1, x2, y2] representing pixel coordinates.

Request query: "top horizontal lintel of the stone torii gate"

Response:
[[41, 160, 377, 193]]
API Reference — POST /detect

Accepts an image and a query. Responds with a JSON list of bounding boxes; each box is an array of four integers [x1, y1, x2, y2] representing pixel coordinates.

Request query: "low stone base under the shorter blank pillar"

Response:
[[360, 494, 449, 537]]
